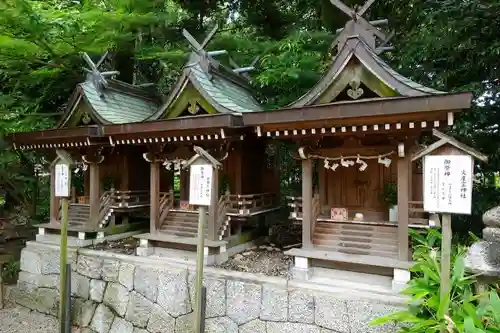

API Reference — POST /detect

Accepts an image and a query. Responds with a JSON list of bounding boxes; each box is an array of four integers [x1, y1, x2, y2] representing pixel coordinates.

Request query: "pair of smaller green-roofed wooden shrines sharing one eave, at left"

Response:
[[10, 29, 279, 249]]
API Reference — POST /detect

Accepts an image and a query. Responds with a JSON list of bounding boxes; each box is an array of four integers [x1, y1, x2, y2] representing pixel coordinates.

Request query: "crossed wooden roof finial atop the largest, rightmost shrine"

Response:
[[330, 0, 394, 53]]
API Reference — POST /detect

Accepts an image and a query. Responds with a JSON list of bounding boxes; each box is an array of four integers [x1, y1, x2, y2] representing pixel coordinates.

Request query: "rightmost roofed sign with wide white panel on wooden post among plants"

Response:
[[412, 130, 488, 332]]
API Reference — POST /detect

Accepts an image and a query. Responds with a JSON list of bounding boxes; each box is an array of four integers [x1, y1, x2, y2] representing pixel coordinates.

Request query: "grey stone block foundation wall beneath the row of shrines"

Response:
[[14, 242, 402, 333]]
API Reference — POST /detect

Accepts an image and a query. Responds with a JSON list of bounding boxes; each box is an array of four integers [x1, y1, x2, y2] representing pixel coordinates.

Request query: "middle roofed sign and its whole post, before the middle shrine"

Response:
[[185, 147, 220, 333]]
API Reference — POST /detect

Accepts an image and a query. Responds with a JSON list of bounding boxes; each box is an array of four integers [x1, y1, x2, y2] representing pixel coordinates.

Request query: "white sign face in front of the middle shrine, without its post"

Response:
[[189, 164, 213, 206]]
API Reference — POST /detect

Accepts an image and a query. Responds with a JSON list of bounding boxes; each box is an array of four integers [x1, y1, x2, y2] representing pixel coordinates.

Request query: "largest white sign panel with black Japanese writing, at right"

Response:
[[424, 155, 473, 215]]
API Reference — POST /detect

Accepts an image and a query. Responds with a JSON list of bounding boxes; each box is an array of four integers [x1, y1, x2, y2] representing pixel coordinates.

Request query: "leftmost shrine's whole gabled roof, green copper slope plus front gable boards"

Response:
[[59, 79, 159, 127]]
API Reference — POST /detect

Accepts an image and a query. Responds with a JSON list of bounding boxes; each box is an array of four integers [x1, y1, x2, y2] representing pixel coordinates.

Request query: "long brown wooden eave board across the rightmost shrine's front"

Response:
[[242, 92, 472, 126]]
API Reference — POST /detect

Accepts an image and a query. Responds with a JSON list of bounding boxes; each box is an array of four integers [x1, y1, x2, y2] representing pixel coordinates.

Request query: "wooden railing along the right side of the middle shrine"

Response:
[[228, 193, 279, 216]]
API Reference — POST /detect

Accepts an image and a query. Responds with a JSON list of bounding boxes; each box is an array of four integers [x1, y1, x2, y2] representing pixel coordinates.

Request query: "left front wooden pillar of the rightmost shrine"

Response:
[[302, 159, 313, 248]]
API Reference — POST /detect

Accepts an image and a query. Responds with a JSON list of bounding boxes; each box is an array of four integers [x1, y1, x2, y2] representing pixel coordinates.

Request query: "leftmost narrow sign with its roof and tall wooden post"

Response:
[[54, 150, 73, 333]]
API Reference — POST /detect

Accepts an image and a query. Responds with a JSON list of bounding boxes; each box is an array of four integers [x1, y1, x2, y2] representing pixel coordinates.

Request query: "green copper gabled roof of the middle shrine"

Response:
[[150, 52, 263, 120]]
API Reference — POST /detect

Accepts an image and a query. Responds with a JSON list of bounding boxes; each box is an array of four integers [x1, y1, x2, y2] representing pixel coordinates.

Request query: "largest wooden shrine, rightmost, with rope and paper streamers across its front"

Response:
[[243, 0, 472, 286]]
